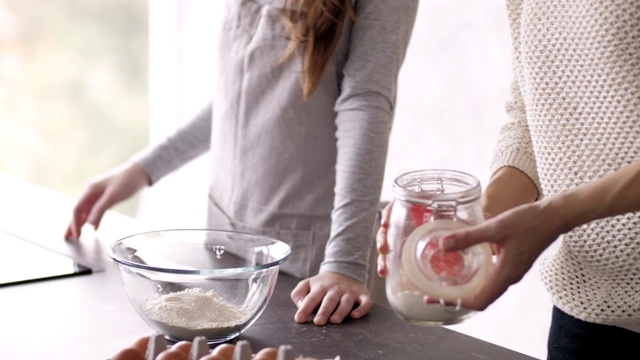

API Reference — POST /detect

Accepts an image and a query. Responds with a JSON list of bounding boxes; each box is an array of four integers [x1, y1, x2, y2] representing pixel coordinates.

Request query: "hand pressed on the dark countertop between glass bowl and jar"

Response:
[[291, 272, 373, 326]]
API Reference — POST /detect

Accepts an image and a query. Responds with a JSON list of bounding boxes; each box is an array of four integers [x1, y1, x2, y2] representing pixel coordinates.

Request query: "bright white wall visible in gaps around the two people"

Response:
[[139, 0, 550, 358]]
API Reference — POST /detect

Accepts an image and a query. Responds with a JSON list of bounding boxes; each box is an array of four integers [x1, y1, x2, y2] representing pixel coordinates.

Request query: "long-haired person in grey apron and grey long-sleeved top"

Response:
[[65, 0, 418, 325]]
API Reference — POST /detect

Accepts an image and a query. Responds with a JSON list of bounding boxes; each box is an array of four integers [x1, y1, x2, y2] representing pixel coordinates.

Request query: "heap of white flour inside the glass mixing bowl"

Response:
[[142, 288, 251, 341]]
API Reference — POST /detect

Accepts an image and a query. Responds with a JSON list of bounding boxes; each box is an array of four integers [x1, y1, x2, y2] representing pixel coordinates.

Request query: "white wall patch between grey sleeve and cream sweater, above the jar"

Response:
[[384, 0, 511, 197]]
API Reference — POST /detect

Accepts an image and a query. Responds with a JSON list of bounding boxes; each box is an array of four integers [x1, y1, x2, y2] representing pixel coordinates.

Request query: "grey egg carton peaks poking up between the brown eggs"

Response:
[[145, 334, 340, 360]]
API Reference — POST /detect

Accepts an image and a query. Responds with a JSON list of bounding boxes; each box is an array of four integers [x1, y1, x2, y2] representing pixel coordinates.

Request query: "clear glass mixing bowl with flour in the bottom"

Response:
[[109, 229, 291, 343]]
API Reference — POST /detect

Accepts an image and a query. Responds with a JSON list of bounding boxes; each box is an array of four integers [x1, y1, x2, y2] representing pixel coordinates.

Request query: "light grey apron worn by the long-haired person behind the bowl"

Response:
[[208, 0, 339, 278]]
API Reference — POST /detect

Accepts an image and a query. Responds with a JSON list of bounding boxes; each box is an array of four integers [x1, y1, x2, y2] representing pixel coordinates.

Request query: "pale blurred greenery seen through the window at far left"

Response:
[[0, 0, 149, 216]]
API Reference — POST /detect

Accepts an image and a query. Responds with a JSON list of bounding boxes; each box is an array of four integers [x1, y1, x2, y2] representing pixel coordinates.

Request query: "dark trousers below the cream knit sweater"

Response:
[[547, 306, 640, 360]]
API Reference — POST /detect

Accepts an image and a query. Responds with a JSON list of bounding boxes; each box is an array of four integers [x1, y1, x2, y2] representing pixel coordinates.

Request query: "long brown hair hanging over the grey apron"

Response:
[[280, 0, 356, 100]]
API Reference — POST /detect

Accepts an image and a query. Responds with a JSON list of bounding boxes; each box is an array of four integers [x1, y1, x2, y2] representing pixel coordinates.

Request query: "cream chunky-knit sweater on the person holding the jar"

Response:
[[492, 0, 640, 332]]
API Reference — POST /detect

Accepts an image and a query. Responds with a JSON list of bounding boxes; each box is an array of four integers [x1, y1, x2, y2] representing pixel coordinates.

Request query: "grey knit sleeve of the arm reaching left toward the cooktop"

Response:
[[132, 105, 212, 185]]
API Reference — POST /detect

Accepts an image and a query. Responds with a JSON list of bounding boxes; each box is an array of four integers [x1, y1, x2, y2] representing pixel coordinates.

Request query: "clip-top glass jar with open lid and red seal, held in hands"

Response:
[[386, 170, 492, 325]]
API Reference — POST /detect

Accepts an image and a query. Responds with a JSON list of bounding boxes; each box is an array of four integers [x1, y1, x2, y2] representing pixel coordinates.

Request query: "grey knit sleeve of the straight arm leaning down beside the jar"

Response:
[[320, 0, 418, 282]]
